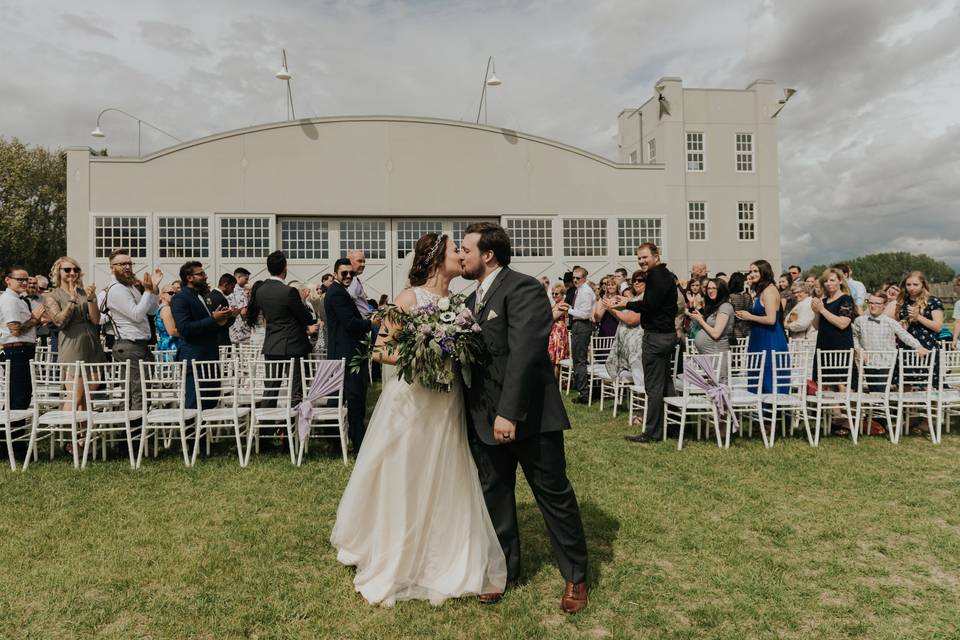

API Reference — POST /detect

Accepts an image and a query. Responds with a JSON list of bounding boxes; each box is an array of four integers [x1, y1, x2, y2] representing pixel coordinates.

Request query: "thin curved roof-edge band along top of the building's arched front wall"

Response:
[[90, 116, 662, 169]]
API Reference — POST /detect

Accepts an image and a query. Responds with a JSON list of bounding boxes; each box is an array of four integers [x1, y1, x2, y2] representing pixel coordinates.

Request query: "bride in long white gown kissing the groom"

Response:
[[330, 233, 507, 606]]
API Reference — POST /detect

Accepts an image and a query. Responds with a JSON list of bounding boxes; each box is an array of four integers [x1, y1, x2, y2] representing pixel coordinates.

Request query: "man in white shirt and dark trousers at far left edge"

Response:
[[0, 267, 45, 456]]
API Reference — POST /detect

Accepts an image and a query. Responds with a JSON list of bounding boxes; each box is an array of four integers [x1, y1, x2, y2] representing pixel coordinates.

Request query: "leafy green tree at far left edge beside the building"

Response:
[[0, 138, 67, 274]]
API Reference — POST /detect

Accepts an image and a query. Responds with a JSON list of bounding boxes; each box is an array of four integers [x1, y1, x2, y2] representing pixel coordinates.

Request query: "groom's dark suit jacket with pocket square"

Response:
[[467, 267, 570, 445]]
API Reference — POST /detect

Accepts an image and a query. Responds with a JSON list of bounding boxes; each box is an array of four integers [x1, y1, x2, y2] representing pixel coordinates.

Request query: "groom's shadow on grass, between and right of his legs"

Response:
[[517, 500, 620, 586]]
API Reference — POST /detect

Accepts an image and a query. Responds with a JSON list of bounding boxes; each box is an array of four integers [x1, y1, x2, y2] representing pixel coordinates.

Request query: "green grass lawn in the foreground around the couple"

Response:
[[0, 384, 960, 640]]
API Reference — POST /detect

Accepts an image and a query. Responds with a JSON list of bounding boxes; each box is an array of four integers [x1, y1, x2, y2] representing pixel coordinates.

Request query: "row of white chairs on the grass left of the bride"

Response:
[[0, 352, 347, 470]]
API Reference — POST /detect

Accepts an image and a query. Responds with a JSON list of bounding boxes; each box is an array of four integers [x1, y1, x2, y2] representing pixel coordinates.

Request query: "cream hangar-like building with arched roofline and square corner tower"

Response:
[[67, 78, 780, 296]]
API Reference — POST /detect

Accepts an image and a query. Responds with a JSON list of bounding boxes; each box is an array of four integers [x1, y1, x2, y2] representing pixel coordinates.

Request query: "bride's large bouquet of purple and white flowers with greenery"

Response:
[[350, 295, 484, 391]]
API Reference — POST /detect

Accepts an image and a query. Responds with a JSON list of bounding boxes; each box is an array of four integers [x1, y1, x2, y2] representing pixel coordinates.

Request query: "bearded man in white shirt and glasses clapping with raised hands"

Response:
[[99, 249, 163, 410]]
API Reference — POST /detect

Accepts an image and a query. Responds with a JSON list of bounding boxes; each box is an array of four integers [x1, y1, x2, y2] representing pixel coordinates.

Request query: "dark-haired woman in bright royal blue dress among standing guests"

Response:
[[737, 260, 788, 393]]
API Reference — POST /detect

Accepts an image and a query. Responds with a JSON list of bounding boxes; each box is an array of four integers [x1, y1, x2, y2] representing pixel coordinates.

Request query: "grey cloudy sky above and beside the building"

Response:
[[0, 0, 960, 268]]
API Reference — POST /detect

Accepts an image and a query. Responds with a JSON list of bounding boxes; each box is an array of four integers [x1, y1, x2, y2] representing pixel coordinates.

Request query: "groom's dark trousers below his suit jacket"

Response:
[[468, 429, 587, 583]]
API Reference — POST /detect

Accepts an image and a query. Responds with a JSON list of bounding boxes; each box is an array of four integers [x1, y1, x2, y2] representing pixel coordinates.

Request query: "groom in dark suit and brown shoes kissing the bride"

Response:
[[460, 222, 587, 613]]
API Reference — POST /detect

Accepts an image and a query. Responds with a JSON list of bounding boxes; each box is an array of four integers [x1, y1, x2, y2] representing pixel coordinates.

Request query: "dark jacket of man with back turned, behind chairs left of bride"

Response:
[[247, 278, 313, 358]]
